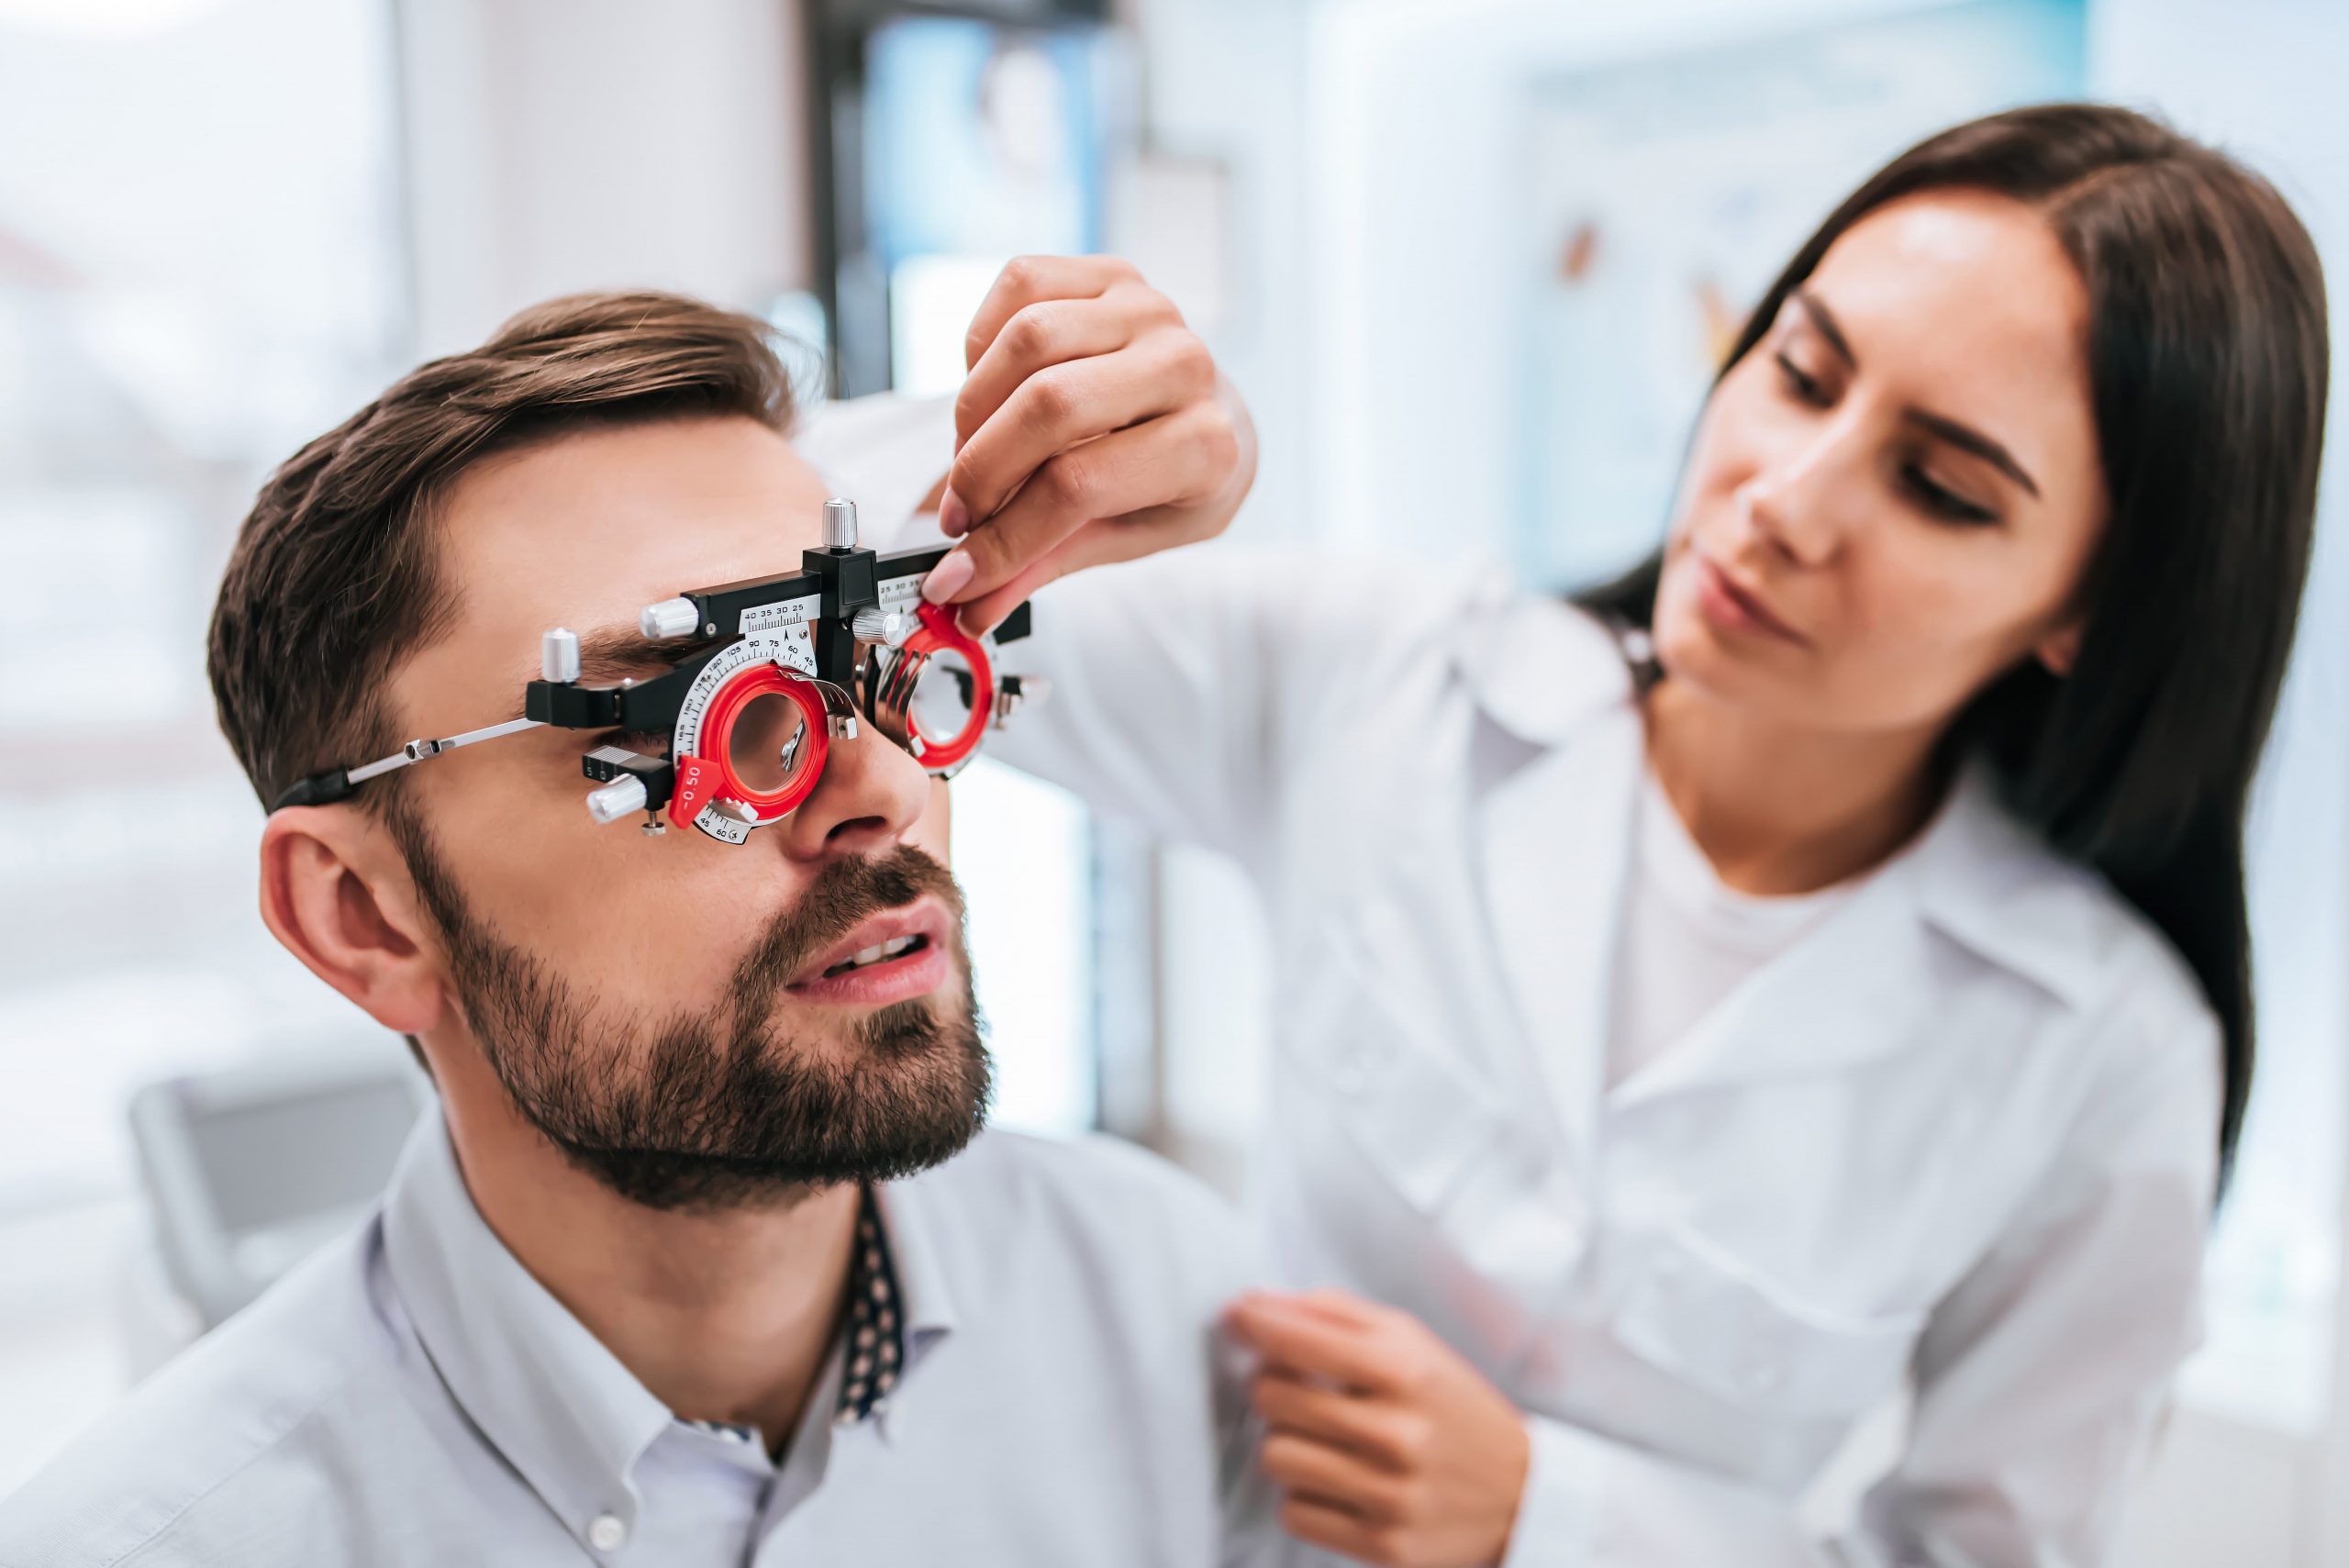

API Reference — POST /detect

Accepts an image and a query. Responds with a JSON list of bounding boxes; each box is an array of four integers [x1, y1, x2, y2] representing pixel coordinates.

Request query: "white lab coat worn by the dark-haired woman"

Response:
[[991, 550, 2220, 1568]]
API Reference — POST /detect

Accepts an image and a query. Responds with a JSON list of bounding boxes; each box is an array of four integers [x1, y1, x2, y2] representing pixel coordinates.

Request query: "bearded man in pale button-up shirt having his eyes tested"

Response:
[[0, 294, 1262, 1568]]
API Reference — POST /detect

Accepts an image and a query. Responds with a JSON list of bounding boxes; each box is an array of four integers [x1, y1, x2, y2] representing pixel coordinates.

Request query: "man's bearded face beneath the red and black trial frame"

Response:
[[390, 417, 986, 1207]]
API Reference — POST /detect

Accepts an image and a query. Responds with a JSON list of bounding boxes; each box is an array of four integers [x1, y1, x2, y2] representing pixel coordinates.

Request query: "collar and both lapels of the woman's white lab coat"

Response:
[[1456, 598, 2102, 1127]]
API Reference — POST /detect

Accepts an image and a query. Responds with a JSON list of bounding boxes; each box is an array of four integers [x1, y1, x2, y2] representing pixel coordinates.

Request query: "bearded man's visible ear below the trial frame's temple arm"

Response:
[[261, 806, 446, 1035]]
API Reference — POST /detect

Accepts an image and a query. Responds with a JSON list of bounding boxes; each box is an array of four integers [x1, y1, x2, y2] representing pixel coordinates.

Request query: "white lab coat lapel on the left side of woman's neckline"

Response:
[[1480, 702, 1642, 1172]]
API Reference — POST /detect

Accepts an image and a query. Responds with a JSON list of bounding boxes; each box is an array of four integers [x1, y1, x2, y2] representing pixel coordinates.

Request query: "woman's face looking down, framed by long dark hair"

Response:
[[1653, 190, 2105, 732]]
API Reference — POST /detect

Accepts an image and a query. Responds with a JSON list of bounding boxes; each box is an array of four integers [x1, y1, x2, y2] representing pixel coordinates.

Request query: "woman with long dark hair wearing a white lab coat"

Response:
[[883, 106, 2325, 1565]]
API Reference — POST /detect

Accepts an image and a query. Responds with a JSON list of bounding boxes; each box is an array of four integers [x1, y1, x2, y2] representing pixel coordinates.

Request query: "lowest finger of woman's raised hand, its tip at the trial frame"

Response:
[[921, 401, 1238, 625]]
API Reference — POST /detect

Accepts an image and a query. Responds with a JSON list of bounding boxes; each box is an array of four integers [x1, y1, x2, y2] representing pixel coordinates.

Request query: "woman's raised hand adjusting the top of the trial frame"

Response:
[[923, 256, 1257, 631]]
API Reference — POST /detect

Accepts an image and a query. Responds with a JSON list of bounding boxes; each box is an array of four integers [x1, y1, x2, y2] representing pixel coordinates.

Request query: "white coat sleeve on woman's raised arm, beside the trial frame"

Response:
[[989, 545, 1498, 869]]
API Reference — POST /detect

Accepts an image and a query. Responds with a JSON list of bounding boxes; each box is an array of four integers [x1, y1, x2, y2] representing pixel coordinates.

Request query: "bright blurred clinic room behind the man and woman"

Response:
[[0, 0, 2349, 1568]]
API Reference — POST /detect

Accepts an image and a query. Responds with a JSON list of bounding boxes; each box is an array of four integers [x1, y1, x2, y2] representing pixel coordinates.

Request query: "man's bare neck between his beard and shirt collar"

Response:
[[435, 1047, 857, 1453]]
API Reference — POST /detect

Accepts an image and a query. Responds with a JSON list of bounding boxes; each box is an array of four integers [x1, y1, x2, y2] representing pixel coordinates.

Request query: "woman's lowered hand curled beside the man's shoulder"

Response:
[[1224, 1291, 1531, 1568]]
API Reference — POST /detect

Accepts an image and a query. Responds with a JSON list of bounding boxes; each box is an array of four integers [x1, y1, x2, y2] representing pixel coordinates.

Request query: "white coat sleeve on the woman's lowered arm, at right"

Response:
[[1503, 967, 2220, 1568]]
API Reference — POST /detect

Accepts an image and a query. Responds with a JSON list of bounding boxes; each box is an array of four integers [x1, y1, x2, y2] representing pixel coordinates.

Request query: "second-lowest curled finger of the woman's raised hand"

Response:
[[947, 333, 1215, 526]]
